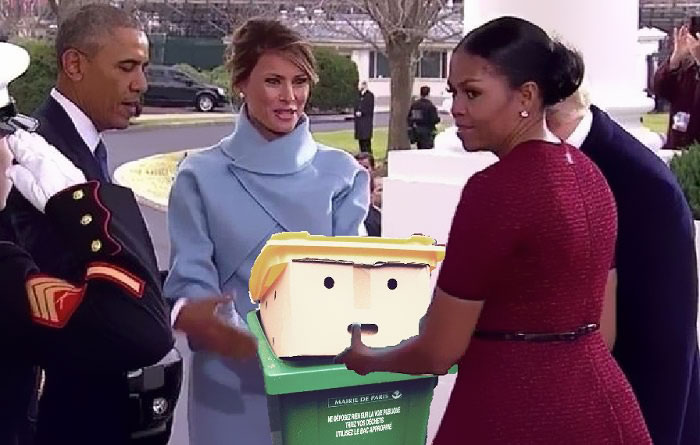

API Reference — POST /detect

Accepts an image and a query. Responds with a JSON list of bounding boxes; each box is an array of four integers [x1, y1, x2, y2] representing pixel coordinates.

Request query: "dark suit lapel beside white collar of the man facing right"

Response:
[[34, 96, 104, 181]]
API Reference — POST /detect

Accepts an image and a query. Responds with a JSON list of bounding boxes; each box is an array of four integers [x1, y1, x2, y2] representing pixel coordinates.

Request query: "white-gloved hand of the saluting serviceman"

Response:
[[7, 130, 86, 212]]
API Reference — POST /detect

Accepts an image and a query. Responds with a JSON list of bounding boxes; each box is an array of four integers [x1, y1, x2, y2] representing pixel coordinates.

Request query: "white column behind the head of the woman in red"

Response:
[[464, 0, 662, 150]]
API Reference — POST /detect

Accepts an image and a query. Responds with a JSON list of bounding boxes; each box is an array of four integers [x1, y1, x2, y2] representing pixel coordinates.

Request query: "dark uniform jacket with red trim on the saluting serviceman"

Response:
[[0, 181, 174, 444]]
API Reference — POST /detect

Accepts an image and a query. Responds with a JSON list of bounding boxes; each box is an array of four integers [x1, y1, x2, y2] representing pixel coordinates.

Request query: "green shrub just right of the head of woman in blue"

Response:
[[309, 48, 359, 112]]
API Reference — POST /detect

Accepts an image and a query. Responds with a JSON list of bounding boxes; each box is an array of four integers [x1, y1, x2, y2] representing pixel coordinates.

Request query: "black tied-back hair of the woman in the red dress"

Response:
[[455, 17, 584, 106]]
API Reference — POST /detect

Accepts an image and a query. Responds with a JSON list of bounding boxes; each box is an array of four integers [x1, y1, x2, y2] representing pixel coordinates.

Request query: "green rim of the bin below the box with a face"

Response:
[[247, 311, 457, 395]]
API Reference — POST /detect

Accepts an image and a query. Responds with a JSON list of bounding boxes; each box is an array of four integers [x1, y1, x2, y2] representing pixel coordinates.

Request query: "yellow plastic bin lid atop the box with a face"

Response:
[[248, 232, 445, 303]]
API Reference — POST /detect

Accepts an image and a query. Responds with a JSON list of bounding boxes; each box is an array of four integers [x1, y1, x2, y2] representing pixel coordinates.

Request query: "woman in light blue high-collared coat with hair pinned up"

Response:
[[165, 20, 369, 445]]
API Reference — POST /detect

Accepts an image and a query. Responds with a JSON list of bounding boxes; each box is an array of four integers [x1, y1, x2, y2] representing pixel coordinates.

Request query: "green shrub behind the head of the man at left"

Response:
[[10, 40, 57, 114]]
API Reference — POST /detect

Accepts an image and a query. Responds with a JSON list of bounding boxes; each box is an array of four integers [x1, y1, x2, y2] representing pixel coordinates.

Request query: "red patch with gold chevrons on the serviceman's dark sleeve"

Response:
[[26, 275, 84, 328]]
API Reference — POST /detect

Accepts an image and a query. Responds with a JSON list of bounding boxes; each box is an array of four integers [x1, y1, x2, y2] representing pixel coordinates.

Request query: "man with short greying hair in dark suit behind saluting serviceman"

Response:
[[6, 5, 168, 443]]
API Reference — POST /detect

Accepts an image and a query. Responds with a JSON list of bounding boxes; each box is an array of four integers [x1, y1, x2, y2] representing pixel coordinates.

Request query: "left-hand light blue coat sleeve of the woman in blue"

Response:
[[164, 168, 221, 300]]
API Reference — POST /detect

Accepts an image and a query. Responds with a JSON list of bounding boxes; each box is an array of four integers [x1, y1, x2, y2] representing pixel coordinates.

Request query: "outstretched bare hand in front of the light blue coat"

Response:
[[174, 298, 258, 360]]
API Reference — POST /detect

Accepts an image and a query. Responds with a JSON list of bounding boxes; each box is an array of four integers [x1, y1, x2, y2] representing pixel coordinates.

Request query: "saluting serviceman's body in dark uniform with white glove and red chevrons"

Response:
[[0, 130, 179, 445]]
